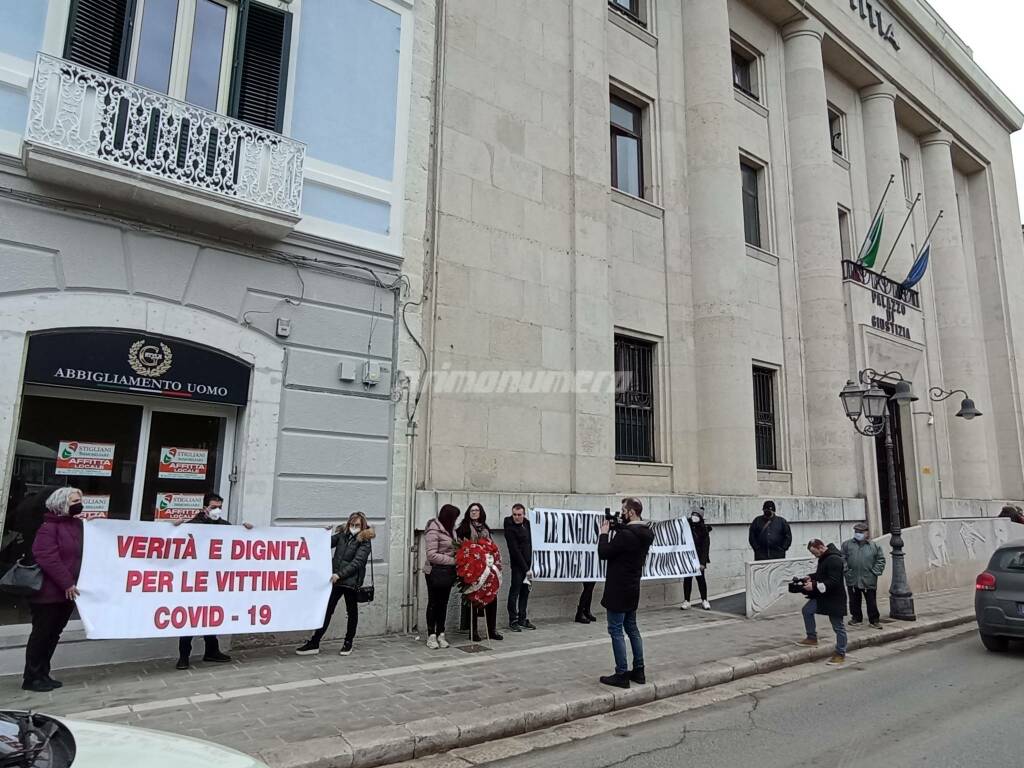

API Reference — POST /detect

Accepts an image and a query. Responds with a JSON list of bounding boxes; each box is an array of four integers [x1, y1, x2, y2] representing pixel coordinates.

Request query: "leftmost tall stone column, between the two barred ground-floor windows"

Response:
[[682, 0, 757, 494]]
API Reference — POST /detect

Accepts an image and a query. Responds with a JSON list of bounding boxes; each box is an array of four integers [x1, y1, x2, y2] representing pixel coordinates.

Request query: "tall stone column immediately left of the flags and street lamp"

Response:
[[782, 20, 859, 497]]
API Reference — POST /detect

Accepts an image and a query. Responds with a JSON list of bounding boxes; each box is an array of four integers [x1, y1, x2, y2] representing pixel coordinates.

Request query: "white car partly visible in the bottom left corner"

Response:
[[0, 711, 267, 768]]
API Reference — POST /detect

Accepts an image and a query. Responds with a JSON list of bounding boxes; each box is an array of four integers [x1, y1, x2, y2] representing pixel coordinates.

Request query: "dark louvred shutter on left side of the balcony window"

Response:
[[63, 0, 135, 78]]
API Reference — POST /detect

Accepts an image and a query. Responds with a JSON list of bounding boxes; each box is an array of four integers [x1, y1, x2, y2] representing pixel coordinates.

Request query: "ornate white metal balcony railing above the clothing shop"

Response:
[[25, 53, 305, 220]]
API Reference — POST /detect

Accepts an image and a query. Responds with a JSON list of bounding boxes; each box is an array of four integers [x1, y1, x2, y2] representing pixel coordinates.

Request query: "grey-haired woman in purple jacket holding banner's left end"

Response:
[[22, 487, 82, 693]]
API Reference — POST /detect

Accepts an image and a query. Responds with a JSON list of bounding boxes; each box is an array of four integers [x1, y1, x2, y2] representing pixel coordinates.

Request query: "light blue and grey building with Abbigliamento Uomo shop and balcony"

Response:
[[0, 0, 430, 672]]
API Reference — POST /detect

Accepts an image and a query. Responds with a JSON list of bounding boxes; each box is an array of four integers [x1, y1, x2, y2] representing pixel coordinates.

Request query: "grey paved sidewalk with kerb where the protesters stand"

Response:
[[0, 588, 974, 768]]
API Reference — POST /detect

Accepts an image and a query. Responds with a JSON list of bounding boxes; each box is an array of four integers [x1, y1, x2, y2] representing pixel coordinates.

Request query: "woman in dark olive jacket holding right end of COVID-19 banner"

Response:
[[295, 512, 377, 656]]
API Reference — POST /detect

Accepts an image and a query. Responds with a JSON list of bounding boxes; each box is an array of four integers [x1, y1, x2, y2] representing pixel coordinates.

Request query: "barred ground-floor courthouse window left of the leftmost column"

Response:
[[615, 335, 655, 462]]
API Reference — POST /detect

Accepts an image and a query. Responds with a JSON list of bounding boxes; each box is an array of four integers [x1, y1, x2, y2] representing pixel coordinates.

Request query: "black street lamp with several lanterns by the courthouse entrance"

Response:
[[839, 368, 981, 622]]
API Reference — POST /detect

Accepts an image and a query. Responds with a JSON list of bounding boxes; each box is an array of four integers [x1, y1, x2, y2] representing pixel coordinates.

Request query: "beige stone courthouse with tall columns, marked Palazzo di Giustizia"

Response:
[[405, 0, 1024, 614]]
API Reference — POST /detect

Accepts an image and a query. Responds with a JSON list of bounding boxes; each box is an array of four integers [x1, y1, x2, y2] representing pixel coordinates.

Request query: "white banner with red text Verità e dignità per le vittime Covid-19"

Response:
[[78, 520, 331, 640]]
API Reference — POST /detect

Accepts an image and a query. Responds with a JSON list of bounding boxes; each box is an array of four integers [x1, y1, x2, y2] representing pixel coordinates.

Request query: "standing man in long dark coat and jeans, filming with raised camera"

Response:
[[597, 498, 654, 688]]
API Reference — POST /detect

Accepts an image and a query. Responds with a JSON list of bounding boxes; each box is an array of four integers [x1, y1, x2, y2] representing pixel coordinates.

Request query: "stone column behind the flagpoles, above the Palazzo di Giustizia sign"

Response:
[[856, 83, 913, 281]]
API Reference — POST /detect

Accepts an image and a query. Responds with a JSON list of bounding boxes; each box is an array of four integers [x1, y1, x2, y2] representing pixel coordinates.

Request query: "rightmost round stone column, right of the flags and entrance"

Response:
[[921, 131, 992, 499]]
